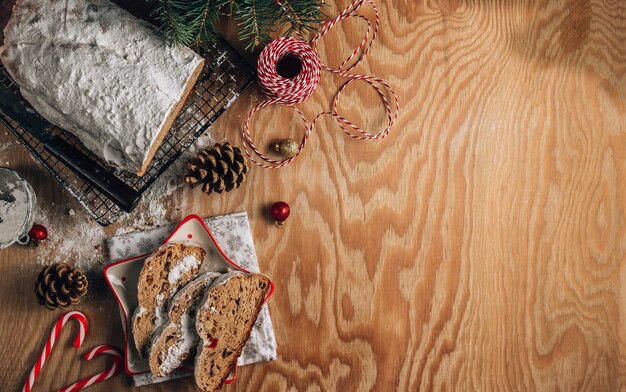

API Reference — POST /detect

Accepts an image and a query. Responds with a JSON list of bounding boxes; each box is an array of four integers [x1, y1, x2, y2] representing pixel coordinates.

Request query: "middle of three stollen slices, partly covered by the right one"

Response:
[[150, 272, 222, 377]]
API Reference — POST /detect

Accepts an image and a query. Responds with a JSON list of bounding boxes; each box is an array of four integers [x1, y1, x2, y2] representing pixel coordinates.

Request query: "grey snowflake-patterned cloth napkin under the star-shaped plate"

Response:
[[108, 212, 276, 386]]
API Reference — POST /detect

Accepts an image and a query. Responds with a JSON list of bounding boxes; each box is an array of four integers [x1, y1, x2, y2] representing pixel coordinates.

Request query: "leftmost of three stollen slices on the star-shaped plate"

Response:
[[133, 244, 206, 355]]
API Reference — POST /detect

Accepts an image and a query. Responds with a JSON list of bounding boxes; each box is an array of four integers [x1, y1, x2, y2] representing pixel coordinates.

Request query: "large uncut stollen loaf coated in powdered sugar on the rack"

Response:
[[0, 0, 204, 175]]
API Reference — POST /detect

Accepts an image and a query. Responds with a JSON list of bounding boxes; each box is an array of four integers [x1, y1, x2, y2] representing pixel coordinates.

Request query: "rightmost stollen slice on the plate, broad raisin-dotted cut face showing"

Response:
[[194, 271, 271, 391]]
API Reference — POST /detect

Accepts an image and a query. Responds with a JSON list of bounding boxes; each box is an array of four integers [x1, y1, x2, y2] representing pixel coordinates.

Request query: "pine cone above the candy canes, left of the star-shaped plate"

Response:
[[35, 263, 88, 310]]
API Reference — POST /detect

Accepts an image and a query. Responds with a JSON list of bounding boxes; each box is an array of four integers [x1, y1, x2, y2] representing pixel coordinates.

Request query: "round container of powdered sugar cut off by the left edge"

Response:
[[0, 167, 36, 249]]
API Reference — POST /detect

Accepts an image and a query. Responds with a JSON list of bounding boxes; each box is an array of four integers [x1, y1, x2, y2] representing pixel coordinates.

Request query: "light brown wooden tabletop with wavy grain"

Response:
[[0, 0, 626, 391]]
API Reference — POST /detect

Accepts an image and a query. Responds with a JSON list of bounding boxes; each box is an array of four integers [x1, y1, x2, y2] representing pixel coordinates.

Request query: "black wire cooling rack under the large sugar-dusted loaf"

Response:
[[0, 0, 254, 226]]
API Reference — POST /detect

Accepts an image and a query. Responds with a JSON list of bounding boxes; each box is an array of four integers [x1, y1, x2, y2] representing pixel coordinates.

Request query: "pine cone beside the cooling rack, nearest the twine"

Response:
[[185, 142, 248, 194]]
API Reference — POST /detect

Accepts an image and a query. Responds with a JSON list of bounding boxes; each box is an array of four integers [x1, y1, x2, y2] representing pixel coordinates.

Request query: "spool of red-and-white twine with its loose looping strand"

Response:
[[242, 0, 400, 169]]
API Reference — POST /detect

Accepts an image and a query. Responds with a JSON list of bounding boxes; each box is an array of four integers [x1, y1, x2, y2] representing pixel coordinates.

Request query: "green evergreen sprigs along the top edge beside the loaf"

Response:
[[151, 0, 323, 49]]
